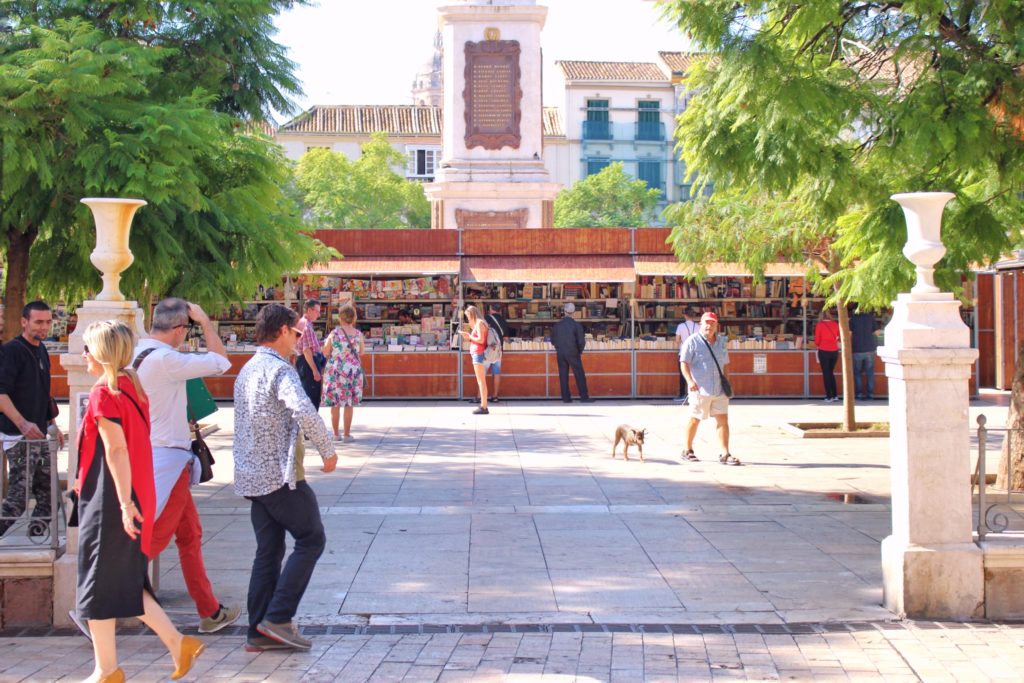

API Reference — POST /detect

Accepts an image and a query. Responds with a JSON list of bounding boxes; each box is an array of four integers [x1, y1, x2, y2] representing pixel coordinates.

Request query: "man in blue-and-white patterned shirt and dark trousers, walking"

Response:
[[233, 304, 338, 650]]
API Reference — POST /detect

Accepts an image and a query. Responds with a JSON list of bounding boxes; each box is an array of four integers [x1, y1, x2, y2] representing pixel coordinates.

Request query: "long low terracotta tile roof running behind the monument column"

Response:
[[278, 104, 565, 137]]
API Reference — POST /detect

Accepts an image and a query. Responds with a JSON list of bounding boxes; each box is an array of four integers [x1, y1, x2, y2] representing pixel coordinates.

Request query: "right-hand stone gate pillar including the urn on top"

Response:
[[879, 193, 984, 620]]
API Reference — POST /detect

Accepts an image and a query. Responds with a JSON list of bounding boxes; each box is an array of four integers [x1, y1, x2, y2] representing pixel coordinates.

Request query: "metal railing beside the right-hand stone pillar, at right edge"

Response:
[[972, 415, 1024, 541]]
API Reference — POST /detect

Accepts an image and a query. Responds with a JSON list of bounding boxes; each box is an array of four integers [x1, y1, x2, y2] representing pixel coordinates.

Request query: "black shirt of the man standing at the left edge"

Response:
[[0, 335, 56, 434]]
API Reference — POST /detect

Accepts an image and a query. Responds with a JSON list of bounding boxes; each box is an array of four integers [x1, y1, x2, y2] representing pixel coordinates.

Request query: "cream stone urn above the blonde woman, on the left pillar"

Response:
[[82, 198, 146, 301]]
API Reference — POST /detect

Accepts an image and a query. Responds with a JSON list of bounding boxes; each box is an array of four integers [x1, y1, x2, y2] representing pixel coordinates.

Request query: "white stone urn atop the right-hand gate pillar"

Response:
[[890, 193, 955, 294]]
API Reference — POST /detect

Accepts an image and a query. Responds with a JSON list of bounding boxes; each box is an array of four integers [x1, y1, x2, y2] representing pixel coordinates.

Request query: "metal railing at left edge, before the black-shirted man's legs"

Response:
[[0, 436, 67, 552]]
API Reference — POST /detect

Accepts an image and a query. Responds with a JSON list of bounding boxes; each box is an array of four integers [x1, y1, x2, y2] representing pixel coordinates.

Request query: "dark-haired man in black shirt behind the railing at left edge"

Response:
[[0, 301, 63, 536]]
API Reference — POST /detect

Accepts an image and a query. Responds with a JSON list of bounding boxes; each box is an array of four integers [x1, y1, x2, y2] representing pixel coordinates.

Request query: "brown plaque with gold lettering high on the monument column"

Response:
[[462, 40, 522, 150]]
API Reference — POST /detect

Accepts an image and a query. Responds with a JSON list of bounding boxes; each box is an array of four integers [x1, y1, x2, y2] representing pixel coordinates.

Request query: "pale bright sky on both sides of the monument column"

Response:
[[276, 0, 687, 118]]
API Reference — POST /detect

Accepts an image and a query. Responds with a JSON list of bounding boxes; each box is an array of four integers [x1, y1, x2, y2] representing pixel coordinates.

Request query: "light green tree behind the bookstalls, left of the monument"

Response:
[[296, 132, 430, 228]]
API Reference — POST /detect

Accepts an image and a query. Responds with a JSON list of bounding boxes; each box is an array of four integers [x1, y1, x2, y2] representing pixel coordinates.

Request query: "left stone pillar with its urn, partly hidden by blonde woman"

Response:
[[53, 199, 145, 627]]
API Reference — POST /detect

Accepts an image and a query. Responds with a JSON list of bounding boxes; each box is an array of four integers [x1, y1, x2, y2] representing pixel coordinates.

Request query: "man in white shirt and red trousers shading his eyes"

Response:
[[132, 299, 242, 633]]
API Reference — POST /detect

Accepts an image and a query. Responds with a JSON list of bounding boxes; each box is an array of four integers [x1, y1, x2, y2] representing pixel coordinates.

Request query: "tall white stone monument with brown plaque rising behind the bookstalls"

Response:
[[424, 0, 559, 229]]
